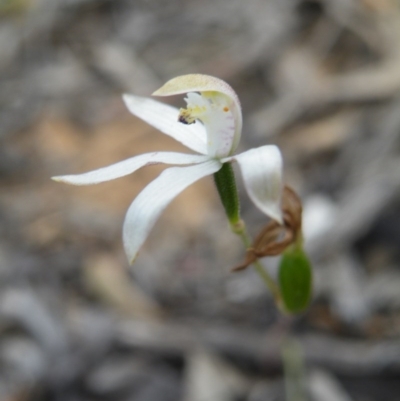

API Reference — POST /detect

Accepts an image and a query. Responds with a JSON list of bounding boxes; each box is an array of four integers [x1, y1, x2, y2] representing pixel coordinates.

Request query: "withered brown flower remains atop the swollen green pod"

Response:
[[232, 186, 302, 271]]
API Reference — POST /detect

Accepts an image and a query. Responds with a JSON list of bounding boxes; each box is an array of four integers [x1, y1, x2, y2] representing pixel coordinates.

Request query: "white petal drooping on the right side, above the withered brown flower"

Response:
[[223, 145, 283, 223]]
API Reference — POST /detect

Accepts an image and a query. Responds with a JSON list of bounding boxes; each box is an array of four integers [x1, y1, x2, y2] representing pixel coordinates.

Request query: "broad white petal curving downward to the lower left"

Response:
[[123, 160, 221, 263]]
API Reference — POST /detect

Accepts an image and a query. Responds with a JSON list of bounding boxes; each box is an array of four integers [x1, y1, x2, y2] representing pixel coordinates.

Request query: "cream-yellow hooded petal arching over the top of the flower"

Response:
[[153, 74, 242, 151]]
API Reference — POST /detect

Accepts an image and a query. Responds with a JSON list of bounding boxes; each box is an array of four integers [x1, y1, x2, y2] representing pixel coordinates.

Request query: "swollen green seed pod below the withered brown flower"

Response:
[[278, 246, 312, 313]]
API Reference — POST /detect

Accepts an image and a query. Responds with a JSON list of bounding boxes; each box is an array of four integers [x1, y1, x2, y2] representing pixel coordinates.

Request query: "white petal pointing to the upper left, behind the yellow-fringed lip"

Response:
[[123, 94, 207, 155]]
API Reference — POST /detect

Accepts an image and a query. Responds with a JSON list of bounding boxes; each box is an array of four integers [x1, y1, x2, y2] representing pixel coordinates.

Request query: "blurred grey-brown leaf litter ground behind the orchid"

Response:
[[0, 0, 400, 401]]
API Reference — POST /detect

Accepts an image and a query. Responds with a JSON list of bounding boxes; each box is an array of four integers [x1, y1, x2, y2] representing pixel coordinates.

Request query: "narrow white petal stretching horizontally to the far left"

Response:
[[52, 152, 209, 185]]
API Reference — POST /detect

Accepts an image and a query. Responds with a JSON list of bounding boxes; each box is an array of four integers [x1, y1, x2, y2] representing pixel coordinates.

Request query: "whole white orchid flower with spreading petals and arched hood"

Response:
[[53, 74, 282, 263]]
